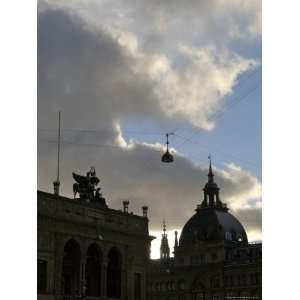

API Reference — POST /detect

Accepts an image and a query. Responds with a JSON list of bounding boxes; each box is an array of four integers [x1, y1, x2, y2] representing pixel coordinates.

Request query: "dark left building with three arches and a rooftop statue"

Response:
[[37, 168, 152, 300]]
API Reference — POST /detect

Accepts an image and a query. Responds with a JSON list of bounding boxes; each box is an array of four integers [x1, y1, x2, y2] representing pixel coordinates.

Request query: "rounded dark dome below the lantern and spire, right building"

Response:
[[179, 207, 248, 247]]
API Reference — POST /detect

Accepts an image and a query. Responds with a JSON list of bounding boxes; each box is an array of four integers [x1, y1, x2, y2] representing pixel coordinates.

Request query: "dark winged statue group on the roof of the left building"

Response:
[[72, 167, 106, 206]]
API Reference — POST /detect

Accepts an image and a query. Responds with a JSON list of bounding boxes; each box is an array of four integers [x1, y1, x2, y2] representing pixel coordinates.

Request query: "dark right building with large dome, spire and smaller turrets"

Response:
[[148, 163, 261, 300]]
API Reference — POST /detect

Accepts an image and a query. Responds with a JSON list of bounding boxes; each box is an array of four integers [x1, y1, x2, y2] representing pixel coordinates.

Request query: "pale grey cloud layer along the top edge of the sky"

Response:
[[39, 0, 261, 51]]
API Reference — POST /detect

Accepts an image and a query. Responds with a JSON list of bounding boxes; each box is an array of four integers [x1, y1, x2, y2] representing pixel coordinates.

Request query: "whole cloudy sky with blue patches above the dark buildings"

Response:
[[37, 0, 262, 258]]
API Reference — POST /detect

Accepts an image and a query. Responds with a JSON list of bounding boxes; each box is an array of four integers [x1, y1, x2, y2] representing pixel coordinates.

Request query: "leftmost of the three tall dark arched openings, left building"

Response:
[[62, 240, 81, 295]]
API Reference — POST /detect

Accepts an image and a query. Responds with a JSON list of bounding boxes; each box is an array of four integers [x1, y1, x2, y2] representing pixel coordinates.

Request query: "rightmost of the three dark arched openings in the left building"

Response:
[[107, 248, 122, 299]]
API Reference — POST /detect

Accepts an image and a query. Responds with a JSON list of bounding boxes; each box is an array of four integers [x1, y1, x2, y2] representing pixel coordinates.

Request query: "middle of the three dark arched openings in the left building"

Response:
[[85, 244, 102, 297]]
